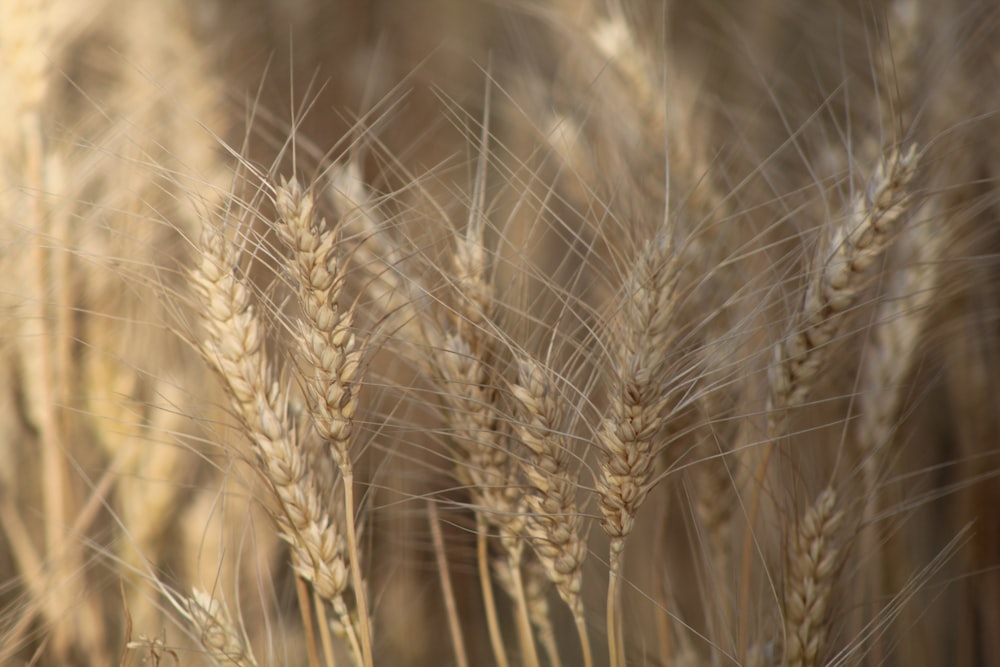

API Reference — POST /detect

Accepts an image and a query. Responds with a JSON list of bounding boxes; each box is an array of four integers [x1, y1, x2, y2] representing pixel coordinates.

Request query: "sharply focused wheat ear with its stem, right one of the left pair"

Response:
[[275, 180, 373, 667]]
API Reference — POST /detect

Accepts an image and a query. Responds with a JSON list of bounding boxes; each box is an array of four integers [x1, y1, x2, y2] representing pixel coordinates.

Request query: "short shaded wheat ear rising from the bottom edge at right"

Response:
[[782, 488, 844, 667]]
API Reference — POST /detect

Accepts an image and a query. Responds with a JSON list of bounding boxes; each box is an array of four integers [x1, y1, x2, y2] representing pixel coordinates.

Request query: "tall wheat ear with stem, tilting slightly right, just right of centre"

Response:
[[597, 233, 677, 667]]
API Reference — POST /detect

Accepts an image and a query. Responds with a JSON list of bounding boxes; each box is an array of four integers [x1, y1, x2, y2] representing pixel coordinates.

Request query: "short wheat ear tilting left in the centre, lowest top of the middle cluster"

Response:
[[511, 357, 593, 667]]
